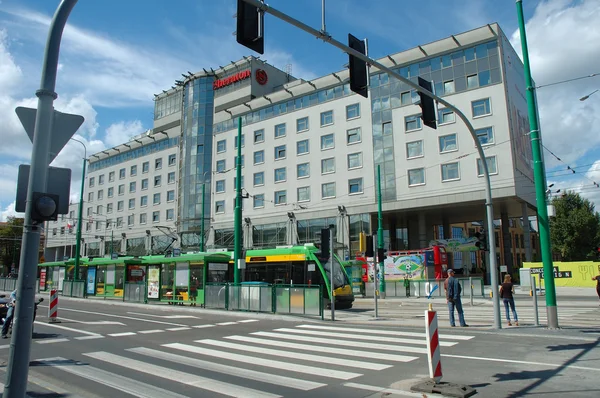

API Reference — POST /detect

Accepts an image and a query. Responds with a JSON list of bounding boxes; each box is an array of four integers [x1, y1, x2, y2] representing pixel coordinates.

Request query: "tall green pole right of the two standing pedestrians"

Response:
[[516, 0, 558, 329]]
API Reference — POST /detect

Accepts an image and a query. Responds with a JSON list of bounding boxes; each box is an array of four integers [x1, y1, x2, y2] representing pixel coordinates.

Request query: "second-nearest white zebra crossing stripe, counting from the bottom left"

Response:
[[83, 351, 280, 398]]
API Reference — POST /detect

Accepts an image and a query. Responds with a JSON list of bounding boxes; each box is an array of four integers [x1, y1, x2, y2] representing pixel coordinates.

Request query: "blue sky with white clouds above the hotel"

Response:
[[0, 0, 600, 221]]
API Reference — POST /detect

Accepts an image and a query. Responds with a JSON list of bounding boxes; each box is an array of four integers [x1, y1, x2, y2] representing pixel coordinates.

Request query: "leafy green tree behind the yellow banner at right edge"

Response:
[[550, 192, 600, 261]]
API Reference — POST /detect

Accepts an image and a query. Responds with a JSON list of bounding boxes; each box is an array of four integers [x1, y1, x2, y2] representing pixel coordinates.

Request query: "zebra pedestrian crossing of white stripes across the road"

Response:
[[35, 323, 474, 398]]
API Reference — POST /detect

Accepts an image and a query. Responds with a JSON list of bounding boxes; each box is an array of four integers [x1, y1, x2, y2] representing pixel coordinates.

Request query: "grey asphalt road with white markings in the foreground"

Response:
[[0, 300, 600, 398]]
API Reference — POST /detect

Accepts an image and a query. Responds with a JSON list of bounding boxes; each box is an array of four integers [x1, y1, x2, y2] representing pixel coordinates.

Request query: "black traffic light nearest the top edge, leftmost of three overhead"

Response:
[[235, 0, 265, 54]]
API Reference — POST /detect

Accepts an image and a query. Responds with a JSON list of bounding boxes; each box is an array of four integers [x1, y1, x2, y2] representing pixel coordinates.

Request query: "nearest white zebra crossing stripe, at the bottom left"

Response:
[[30, 357, 185, 398]]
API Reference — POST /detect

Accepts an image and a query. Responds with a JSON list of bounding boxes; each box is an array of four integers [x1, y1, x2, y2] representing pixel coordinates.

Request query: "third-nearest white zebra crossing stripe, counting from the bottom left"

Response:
[[127, 347, 327, 391]]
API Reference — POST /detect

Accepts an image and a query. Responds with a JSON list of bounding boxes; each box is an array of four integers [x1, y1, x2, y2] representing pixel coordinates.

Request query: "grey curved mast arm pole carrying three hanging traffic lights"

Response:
[[242, 0, 502, 329]]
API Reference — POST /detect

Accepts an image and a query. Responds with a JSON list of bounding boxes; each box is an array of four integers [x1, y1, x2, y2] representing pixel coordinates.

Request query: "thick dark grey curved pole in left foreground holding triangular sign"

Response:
[[2, 0, 77, 398]]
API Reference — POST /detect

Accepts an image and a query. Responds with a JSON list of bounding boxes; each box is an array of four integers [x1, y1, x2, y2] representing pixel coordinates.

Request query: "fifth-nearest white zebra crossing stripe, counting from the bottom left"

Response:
[[195, 339, 392, 370]]
